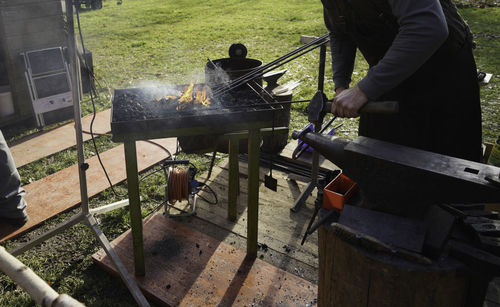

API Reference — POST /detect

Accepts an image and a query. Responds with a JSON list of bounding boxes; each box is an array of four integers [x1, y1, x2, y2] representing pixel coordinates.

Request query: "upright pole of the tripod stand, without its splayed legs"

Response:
[[65, 0, 89, 214]]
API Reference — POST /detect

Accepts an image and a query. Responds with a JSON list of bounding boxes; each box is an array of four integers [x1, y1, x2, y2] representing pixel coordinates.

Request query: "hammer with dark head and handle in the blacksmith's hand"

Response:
[[307, 91, 399, 125]]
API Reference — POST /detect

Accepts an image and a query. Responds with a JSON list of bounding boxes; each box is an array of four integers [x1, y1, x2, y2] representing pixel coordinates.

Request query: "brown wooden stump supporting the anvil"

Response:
[[318, 226, 469, 307]]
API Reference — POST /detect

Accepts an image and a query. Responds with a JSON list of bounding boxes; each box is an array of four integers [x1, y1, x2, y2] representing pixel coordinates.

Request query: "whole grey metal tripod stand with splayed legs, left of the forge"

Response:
[[10, 0, 149, 306]]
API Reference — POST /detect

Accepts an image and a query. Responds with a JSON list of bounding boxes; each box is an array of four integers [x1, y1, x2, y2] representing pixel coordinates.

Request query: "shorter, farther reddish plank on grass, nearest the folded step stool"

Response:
[[10, 109, 111, 167]]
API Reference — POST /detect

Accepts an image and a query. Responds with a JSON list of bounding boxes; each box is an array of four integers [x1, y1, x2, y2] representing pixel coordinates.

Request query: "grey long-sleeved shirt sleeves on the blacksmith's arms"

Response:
[[325, 0, 448, 100]]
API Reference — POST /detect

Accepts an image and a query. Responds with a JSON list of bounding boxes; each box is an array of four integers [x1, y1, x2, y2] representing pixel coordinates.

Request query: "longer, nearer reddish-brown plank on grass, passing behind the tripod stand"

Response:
[[0, 138, 177, 242]]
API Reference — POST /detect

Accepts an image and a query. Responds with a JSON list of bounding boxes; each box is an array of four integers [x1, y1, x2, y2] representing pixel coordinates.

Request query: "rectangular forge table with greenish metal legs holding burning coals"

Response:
[[111, 94, 286, 276]]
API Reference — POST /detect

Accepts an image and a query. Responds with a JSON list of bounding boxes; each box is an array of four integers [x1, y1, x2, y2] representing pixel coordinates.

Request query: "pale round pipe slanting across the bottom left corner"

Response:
[[0, 246, 84, 307]]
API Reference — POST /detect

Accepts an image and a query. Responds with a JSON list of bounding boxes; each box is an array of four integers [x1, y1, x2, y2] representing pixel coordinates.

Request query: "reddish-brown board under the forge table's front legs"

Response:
[[93, 213, 317, 306]]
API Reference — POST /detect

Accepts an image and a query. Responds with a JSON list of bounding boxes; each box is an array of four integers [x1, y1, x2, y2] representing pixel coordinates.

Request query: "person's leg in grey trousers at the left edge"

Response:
[[0, 131, 28, 226]]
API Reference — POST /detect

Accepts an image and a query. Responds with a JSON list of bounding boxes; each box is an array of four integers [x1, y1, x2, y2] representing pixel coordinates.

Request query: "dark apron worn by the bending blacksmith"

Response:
[[323, 0, 482, 161]]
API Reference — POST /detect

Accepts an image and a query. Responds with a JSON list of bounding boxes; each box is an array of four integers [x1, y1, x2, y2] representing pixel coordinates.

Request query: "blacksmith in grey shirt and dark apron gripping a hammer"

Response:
[[322, 0, 482, 161]]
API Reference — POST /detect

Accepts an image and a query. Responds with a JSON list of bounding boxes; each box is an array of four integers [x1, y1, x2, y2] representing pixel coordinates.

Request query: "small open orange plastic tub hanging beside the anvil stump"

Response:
[[323, 173, 358, 210]]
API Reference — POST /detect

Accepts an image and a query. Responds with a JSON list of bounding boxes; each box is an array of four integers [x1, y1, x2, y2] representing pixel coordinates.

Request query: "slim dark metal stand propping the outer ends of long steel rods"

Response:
[[290, 41, 328, 212]]
